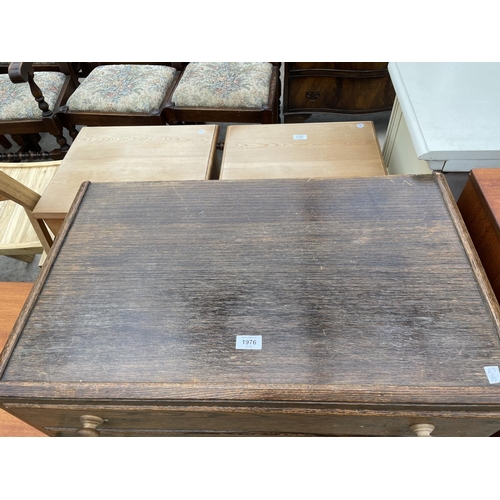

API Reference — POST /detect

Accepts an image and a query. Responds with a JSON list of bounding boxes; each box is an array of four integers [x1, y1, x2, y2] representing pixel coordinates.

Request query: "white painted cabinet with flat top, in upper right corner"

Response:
[[383, 63, 500, 174]]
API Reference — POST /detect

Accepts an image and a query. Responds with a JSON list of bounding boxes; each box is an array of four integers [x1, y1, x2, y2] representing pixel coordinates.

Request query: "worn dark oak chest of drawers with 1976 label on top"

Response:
[[0, 178, 500, 436]]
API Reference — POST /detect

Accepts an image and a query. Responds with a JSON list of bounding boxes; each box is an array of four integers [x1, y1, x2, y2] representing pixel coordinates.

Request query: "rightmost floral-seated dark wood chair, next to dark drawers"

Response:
[[164, 62, 280, 125]]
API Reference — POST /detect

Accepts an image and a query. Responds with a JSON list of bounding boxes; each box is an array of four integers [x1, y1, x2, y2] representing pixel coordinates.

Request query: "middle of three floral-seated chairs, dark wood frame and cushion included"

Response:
[[58, 63, 180, 138]]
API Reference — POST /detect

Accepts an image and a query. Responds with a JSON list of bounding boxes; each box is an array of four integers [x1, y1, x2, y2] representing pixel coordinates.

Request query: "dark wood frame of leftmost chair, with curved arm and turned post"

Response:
[[0, 62, 77, 161]]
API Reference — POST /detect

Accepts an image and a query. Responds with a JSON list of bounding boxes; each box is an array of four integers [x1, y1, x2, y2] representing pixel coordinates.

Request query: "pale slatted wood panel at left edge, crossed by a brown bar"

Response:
[[0, 161, 60, 255]]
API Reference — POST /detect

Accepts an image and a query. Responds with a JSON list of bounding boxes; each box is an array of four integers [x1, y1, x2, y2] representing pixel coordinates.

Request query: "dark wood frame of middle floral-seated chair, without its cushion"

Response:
[[57, 63, 183, 139]]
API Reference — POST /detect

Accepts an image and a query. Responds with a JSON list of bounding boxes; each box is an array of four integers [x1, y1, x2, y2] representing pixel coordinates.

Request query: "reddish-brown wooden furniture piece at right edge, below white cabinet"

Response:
[[457, 168, 500, 300]]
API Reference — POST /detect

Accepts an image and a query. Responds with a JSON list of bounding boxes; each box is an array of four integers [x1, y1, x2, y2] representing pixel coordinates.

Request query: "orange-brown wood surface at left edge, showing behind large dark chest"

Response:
[[0, 282, 44, 437]]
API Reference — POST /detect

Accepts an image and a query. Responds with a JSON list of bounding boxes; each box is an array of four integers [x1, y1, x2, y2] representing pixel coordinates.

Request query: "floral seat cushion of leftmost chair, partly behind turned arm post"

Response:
[[0, 71, 66, 121]]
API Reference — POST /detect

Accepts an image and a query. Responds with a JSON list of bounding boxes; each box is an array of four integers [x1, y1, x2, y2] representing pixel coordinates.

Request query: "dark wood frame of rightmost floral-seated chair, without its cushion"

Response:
[[163, 62, 281, 125]]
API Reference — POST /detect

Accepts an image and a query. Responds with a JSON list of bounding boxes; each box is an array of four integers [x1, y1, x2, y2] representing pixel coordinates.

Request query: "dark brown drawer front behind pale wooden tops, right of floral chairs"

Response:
[[288, 76, 396, 112]]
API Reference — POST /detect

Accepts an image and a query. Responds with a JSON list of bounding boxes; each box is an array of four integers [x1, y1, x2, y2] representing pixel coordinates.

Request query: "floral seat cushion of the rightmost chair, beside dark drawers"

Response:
[[172, 62, 272, 108]]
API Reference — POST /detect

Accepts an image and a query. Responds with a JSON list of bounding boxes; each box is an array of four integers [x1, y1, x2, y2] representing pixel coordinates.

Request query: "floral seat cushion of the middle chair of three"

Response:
[[66, 64, 176, 113]]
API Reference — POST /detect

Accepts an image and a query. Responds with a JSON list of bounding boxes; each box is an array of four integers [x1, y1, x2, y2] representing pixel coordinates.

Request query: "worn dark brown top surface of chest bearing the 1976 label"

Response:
[[2, 176, 500, 399]]
